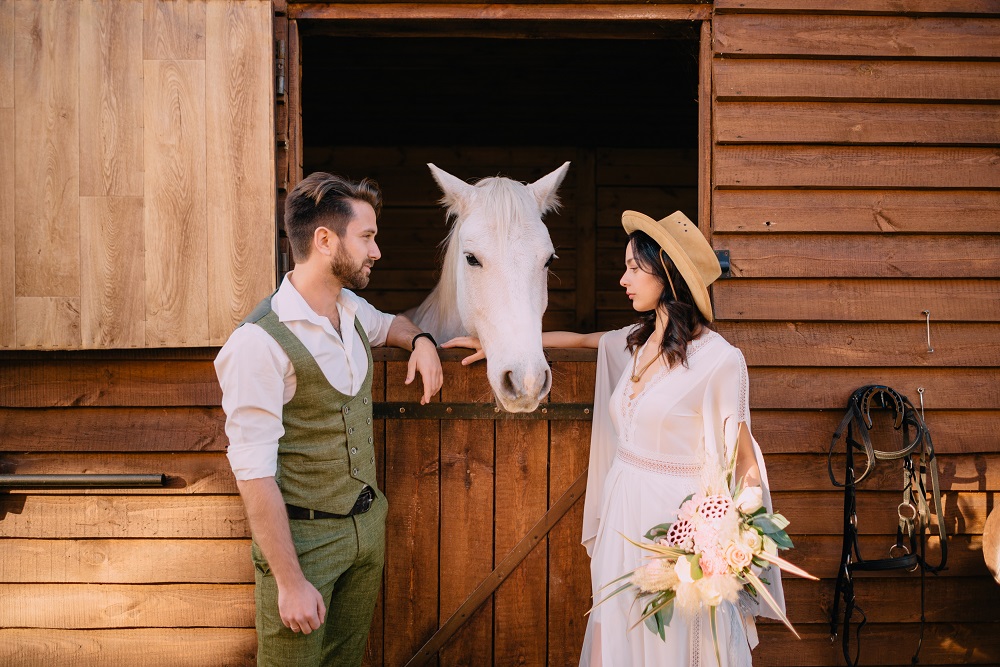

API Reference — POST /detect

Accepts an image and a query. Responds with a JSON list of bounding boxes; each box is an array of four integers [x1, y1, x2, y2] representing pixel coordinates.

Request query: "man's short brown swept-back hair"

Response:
[[285, 171, 382, 262]]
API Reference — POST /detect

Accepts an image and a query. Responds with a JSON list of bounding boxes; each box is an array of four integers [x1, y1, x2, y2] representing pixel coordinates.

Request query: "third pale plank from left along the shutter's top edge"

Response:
[[80, 0, 143, 198]]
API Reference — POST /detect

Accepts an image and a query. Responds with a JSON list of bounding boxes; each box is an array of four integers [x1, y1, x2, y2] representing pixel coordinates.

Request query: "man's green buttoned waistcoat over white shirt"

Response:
[[244, 297, 378, 514]]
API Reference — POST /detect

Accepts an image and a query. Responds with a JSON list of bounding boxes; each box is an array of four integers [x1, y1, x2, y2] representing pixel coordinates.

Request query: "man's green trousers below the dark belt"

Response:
[[252, 493, 388, 667]]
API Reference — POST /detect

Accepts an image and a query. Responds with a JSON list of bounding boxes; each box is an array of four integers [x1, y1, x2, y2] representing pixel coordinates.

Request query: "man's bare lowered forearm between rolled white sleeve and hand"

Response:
[[236, 477, 303, 585]]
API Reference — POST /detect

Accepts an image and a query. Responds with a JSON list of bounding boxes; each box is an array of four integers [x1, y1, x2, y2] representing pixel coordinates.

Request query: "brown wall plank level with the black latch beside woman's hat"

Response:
[[713, 234, 1000, 278]]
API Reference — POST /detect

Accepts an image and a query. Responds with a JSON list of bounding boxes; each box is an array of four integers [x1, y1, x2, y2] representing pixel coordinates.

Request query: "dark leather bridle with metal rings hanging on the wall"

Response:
[[827, 385, 948, 667]]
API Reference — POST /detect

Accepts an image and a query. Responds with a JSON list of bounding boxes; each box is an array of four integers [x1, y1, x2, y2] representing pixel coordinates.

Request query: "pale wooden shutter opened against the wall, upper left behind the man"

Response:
[[0, 0, 275, 349]]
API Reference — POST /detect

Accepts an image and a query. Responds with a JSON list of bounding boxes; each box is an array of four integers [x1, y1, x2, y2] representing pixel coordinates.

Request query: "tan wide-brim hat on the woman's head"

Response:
[[622, 211, 722, 322]]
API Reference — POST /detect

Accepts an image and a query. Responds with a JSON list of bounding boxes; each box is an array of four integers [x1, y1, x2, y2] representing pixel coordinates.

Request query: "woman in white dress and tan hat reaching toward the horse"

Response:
[[445, 211, 783, 667]]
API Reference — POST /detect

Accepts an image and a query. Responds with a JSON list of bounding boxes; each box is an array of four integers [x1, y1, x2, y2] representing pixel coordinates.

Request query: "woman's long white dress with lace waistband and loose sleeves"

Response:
[[580, 327, 783, 667]]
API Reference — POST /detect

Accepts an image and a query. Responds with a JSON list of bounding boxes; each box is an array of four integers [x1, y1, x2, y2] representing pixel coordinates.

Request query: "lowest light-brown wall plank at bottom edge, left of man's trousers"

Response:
[[0, 628, 257, 667]]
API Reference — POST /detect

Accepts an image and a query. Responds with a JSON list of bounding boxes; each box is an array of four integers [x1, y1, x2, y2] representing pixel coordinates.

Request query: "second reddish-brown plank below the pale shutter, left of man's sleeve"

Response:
[[0, 404, 228, 452]]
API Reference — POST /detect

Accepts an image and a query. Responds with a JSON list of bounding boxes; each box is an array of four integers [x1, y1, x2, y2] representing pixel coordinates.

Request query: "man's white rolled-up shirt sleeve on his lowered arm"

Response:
[[215, 324, 292, 480]]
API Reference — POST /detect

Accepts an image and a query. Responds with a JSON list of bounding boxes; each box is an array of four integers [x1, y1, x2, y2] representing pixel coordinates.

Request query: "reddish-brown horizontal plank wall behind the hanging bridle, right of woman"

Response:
[[711, 0, 1000, 665]]
